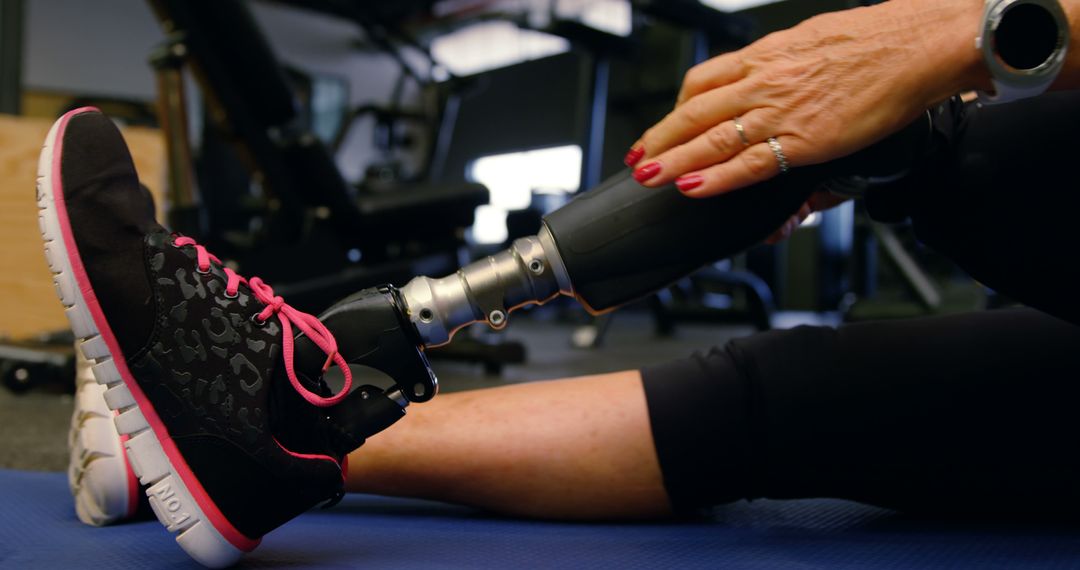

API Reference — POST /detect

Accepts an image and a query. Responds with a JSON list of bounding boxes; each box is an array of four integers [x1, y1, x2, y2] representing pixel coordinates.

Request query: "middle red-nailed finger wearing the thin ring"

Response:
[[635, 109, 774, 190]]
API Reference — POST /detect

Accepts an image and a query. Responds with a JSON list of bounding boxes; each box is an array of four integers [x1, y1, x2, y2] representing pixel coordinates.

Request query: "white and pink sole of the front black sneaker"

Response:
[[37, 109, 258, 568]]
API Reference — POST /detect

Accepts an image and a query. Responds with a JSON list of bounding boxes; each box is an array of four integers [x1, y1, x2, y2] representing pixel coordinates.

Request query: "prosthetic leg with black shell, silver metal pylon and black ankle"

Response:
[[297, 106, 932, 446]]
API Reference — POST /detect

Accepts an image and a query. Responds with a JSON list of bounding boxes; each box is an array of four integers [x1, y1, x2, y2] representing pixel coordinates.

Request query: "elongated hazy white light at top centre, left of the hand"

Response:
[[431, 22, 570, 76]]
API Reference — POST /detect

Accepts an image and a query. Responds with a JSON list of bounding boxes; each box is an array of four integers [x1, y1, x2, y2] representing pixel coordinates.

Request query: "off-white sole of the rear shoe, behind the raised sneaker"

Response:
[[68, 351, 138, 527]]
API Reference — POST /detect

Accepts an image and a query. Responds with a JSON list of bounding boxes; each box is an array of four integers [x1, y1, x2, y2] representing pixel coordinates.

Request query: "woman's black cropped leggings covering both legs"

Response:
[[643, 93, 1080, 513]]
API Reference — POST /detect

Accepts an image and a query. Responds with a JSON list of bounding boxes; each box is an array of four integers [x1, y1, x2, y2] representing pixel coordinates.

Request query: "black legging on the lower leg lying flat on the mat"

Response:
[[643, 309, 1080, 512]]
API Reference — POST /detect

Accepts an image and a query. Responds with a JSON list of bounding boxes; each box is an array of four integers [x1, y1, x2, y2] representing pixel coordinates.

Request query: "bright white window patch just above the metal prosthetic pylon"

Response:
[[469, 145, 581, 244]]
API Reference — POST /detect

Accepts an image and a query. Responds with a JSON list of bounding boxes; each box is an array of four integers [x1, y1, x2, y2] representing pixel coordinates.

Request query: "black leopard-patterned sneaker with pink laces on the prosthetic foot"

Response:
[[37, 108, 351, 567]]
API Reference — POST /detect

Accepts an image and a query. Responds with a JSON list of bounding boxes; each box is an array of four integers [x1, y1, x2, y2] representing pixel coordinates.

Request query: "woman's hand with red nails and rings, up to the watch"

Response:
[[626, 0, 985, 196]]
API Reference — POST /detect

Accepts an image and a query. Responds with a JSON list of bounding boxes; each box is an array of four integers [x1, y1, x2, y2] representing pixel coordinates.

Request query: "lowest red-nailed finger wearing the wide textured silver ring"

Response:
[[675, 136, 798, 198]]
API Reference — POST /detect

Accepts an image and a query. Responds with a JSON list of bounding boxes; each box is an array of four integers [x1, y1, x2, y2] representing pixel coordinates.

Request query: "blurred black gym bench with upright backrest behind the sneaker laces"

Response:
[[149, 0, 487, 309]]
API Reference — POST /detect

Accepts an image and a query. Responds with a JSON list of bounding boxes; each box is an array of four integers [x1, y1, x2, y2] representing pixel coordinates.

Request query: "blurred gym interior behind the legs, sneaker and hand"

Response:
[[0, 0, 993, 470]]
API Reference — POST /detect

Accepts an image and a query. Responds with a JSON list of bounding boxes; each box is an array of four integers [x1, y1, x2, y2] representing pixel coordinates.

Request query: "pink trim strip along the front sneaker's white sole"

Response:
[[52, 107, 260, 552]]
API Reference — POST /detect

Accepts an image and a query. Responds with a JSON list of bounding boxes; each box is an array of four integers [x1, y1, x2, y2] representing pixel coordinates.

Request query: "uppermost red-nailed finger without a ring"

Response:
[[635, 85, 755, 163]]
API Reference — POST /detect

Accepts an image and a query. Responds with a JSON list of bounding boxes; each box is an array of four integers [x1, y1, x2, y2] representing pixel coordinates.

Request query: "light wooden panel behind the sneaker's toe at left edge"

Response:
[[0, 114, 165, 338]]
